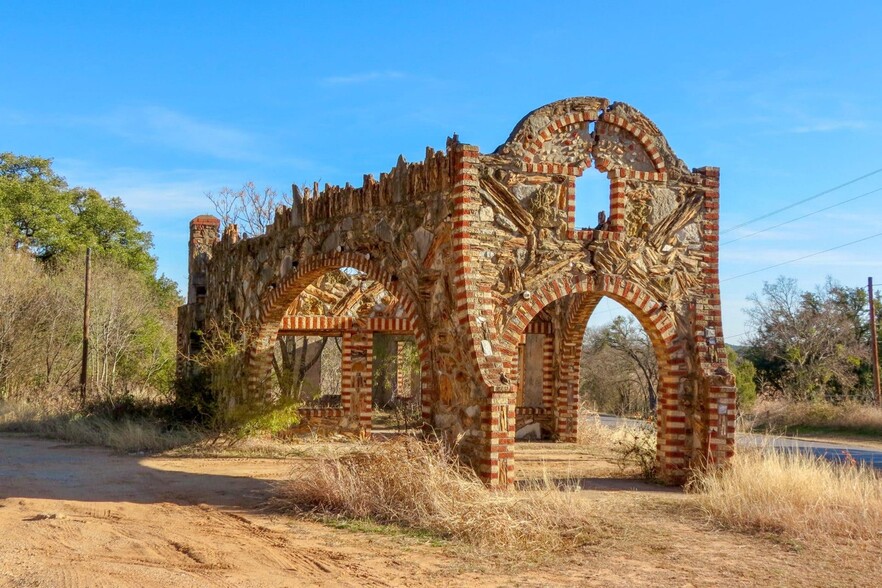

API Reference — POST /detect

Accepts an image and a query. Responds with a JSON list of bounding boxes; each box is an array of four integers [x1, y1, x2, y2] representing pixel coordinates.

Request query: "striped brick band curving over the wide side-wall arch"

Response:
[[245, 252, 433, 420]]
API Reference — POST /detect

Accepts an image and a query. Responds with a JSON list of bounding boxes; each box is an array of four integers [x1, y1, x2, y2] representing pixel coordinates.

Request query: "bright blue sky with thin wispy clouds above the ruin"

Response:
[[0, 1, 882, 343]]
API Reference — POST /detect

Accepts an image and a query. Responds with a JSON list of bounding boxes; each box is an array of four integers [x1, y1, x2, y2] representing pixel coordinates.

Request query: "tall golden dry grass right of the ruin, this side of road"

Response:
[[693, 449, 882, 541]]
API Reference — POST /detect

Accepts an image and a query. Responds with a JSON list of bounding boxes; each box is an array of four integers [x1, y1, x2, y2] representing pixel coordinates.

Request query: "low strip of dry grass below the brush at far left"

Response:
[[0, 402, 200, 453]]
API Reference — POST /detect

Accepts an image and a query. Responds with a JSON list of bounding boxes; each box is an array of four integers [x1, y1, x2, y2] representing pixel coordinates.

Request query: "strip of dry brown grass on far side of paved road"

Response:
[[748, 400, 882, 436]]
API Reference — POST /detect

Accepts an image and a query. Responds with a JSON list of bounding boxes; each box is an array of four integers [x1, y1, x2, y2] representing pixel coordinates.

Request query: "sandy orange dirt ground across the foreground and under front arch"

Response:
[[0, 435, 882, 588]]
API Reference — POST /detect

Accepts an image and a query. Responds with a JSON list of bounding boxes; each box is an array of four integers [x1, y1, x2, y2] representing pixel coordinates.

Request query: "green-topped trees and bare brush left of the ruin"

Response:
[[0, 153, 181, 404]]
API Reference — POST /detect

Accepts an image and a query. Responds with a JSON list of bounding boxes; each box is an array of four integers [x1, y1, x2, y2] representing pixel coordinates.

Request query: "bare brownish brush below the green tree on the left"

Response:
[[0, 250, 175, 404]]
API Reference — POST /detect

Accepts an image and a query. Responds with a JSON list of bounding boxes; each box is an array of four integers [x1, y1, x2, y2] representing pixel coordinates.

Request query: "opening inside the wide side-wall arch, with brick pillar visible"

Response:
[[273, 267, 423, 433]]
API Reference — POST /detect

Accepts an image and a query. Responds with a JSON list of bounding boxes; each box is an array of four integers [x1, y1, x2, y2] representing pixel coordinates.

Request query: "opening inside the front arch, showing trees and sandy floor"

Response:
[[510, 285, 669, 485]]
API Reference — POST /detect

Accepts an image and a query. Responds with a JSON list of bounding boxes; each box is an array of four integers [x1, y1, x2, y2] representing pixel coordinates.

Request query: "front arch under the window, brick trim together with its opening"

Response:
[[498, 278, 685, 480]]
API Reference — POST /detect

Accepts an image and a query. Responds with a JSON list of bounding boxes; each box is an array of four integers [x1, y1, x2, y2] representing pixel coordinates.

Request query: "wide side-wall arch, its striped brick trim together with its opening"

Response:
[[248, 254, 428, 435]]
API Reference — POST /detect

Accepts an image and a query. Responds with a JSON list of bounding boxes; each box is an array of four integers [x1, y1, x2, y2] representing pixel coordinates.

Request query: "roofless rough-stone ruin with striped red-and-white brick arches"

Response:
[[178, 97, 735, 487]]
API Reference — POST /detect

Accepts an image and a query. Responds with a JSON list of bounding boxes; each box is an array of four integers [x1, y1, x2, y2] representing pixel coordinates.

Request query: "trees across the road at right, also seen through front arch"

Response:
[[580, 276, 882, 416]]
